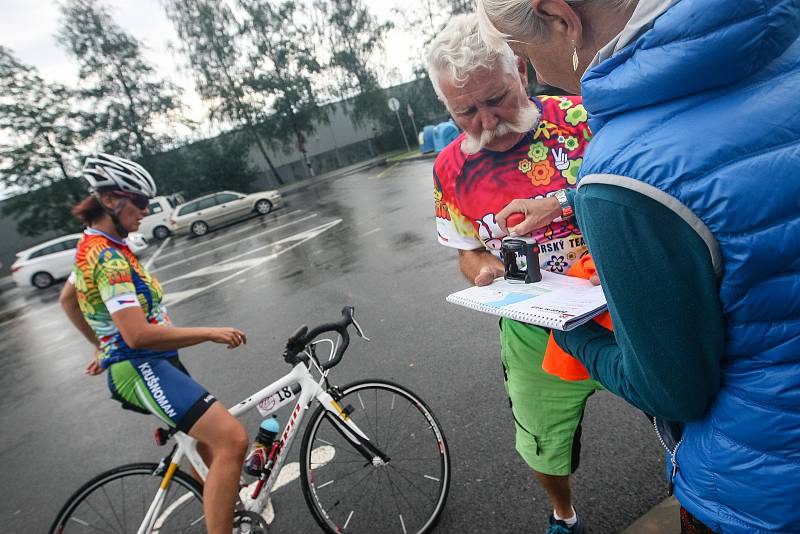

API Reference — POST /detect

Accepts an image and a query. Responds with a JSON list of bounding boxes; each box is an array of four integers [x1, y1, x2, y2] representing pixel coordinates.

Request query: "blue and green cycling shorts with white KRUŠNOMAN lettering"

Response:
[[108, 356, 216, 432]]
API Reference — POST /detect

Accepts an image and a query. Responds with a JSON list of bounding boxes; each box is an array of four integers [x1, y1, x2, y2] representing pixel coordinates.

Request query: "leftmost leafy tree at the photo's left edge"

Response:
[[0, 46, 86, 235]]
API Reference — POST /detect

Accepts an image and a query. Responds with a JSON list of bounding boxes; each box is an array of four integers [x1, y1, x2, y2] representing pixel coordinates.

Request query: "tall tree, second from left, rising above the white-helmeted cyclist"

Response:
[[56, 0, 182, 158]]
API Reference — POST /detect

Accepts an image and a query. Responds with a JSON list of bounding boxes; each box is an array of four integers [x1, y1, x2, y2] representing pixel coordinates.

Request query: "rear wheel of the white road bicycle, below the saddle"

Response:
[[49, 463, 205, 534]]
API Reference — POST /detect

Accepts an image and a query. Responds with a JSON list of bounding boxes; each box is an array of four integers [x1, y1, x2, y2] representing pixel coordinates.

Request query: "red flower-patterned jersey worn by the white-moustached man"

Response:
[[433, 96, 591, 273]]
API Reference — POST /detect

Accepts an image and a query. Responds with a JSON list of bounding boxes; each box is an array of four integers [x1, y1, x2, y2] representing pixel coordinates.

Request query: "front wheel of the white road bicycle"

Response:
[[300, 380, 450, 534]]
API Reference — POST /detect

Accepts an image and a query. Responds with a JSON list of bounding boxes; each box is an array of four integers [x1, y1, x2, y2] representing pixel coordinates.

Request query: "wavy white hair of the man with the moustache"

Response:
[[428, 13, 519, 103]]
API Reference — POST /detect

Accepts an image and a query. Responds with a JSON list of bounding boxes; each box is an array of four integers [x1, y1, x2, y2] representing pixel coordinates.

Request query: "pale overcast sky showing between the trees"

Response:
[[0, 0, 424, 137]]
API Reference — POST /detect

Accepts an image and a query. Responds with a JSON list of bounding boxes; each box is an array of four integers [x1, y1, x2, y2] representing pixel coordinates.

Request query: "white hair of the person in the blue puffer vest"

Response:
[[477, 0, 639, 48]]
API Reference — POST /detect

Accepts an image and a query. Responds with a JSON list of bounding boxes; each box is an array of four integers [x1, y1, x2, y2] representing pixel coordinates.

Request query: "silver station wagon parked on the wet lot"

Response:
[[170, 191, 283, 236]]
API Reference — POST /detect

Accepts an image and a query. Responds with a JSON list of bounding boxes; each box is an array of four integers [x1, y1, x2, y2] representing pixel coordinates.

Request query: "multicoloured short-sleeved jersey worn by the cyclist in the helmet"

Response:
[[73, 228, 178, 368]]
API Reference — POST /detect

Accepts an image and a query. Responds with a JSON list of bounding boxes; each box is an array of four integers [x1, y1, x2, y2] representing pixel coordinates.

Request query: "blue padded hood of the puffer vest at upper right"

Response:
[[581, 0, 800, 131]]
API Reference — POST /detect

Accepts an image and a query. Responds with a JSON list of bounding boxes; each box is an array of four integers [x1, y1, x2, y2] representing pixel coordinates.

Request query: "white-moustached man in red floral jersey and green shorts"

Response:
[[428, 14, 600, 534]]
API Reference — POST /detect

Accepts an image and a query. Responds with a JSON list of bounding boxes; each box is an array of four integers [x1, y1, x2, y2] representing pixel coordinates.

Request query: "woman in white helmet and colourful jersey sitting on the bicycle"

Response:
[[61, 154, 248, 534]]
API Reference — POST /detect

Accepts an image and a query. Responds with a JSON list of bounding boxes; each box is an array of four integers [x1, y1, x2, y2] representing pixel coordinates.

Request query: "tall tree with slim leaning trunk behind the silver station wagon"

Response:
[[163, 0, 284, 184]]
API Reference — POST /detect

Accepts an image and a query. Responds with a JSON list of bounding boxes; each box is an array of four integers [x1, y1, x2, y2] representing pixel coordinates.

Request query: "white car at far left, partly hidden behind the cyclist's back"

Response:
[[11, 234, 83, 289]]
